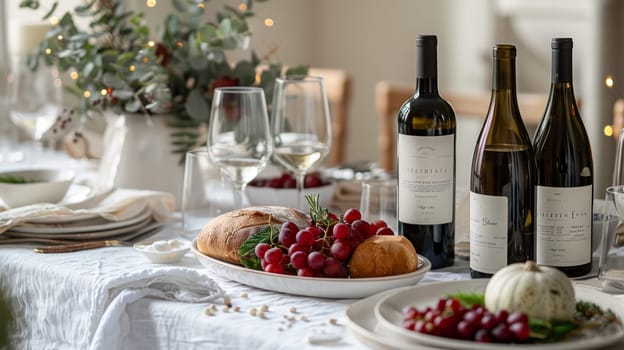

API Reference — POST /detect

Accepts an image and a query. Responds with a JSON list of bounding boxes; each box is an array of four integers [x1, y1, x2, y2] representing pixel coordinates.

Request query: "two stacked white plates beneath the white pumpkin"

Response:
[[346, 280, 624, 350]]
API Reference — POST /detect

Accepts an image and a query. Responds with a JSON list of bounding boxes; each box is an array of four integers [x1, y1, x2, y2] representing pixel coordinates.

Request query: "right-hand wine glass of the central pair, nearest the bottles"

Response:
[[271, 76, 331, 209]]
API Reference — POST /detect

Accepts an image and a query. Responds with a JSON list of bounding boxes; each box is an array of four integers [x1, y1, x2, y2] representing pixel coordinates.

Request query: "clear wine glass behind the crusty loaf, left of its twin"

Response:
[[207, 87, 272, 209]]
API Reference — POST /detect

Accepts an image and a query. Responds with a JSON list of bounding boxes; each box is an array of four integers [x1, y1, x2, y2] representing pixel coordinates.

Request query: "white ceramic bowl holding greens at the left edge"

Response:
[[0, 169, 75, 208]]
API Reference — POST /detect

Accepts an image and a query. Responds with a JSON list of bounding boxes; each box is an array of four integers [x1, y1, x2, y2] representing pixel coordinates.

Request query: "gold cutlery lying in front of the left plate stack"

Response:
[[34, 222, 164, 254]]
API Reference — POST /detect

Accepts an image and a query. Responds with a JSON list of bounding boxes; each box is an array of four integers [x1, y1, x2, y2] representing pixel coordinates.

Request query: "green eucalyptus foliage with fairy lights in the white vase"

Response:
[[20, 0, 307, 153]]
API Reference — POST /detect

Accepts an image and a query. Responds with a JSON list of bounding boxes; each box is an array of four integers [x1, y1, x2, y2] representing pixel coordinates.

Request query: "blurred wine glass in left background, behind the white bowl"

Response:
[[8, 58, 63, 152]]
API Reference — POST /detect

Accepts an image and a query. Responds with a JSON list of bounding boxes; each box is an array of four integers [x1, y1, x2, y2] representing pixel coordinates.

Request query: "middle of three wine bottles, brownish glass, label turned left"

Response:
[[470, 45, 536, 278]]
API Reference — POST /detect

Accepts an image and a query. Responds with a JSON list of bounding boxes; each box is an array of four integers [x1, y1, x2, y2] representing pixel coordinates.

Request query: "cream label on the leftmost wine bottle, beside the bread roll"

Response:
[[397, 134, 455, 225]]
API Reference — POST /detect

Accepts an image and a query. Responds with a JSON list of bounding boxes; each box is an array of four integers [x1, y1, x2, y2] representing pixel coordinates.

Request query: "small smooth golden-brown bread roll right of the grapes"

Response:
[[349, 236, 418, 278]]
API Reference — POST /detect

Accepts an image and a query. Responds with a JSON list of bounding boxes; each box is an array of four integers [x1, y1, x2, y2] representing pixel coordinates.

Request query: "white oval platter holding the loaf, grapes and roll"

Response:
[[191, 240, 431, 299]]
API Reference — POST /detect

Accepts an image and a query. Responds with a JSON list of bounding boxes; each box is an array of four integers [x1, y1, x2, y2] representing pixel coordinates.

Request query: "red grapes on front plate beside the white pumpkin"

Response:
[[403, 298, 530, 343]]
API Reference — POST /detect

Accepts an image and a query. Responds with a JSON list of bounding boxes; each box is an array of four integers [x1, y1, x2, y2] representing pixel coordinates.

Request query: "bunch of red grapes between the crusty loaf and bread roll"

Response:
[[255, 209, 394, 277]]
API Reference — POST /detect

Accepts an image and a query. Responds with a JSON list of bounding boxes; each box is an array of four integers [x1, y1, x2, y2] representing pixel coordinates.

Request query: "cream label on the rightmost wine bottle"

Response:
[[535, 185, 592, 266]]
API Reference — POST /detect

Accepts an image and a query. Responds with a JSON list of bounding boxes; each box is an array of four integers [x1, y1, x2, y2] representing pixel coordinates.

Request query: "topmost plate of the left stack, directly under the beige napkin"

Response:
[[11, 210, 152, 234]]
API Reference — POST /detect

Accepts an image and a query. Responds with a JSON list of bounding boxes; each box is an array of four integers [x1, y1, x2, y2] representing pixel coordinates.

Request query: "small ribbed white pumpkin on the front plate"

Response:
[[485, 261, 576, 321]]
